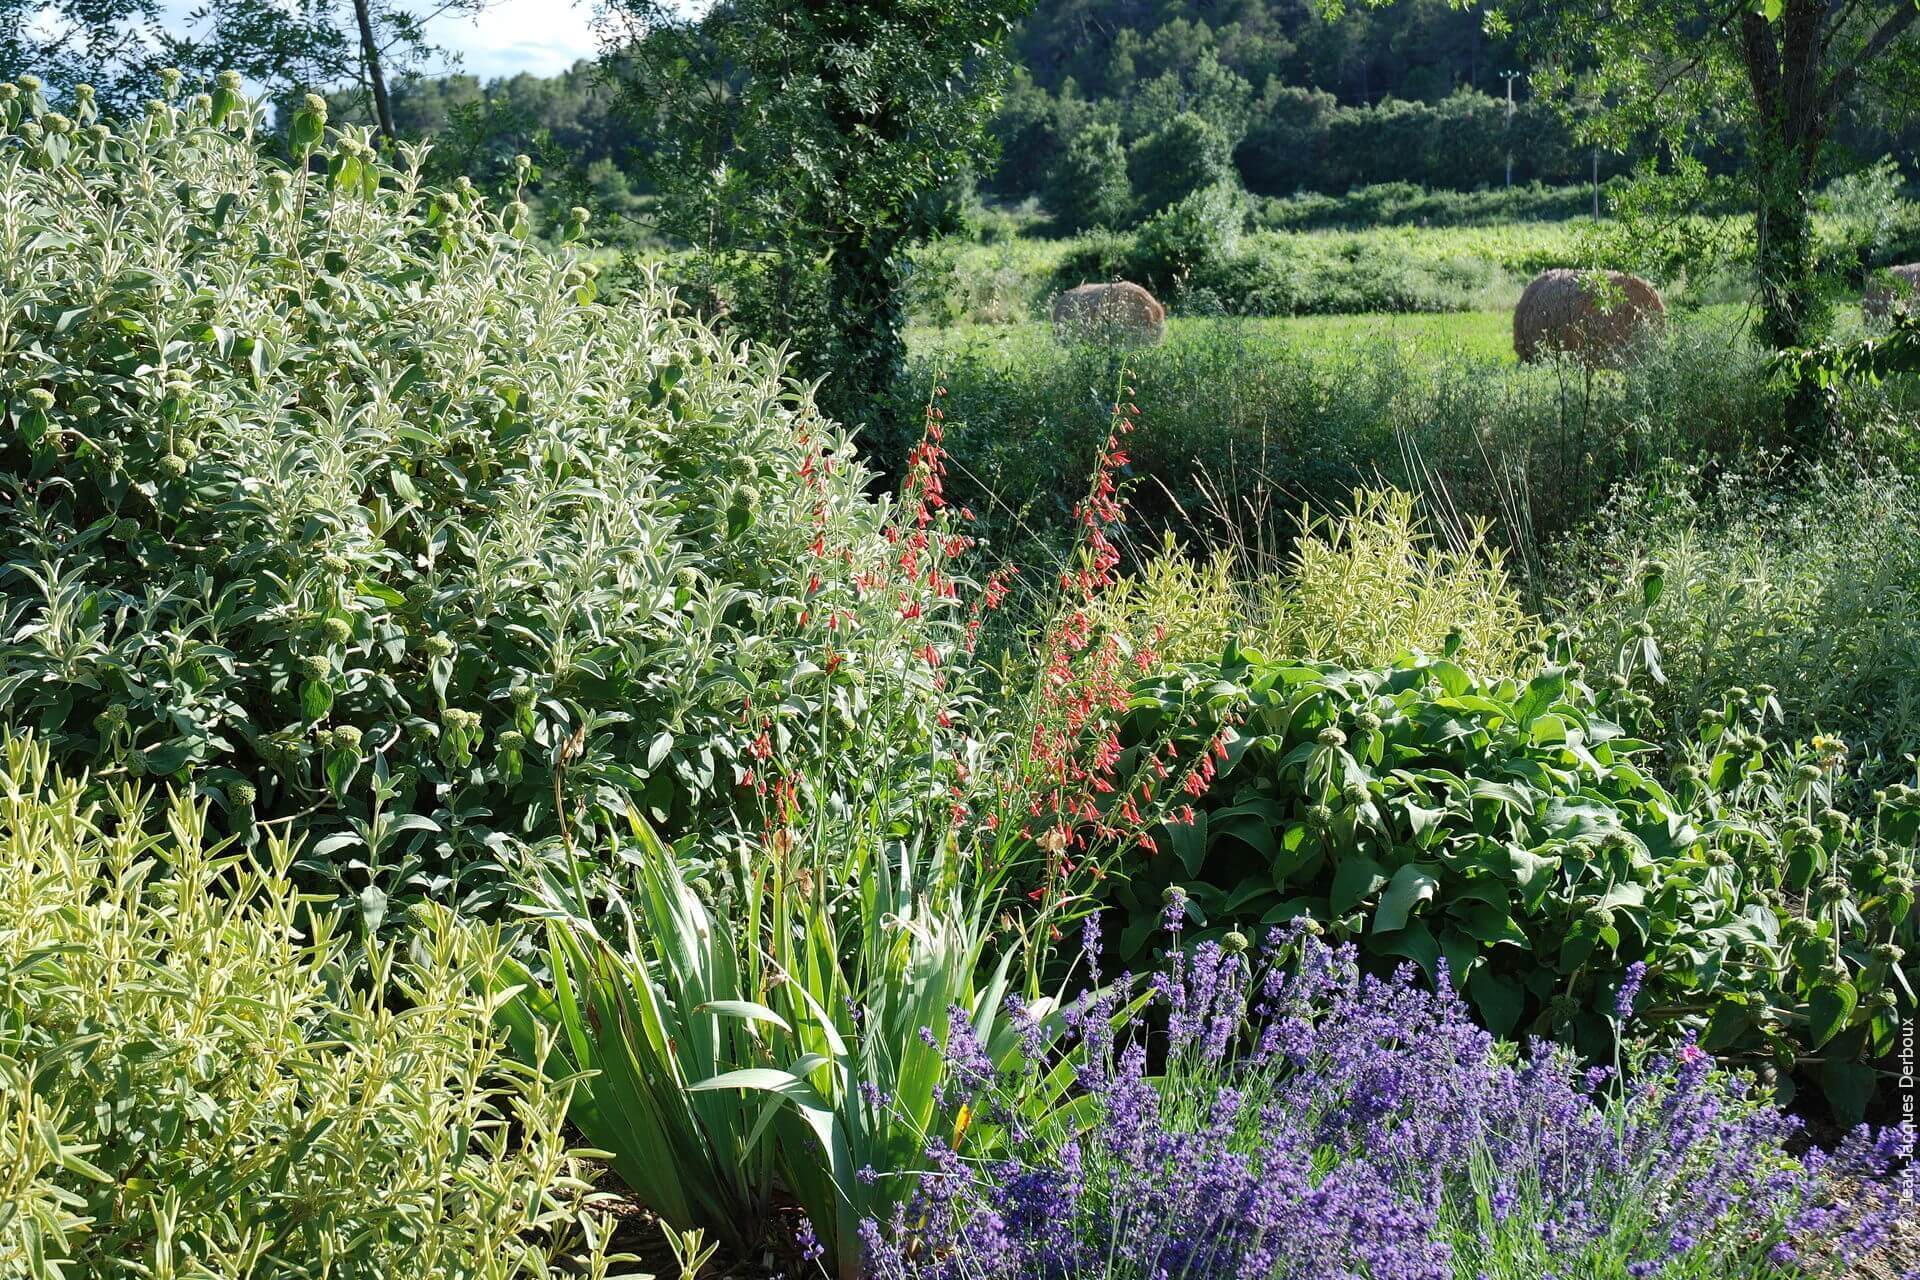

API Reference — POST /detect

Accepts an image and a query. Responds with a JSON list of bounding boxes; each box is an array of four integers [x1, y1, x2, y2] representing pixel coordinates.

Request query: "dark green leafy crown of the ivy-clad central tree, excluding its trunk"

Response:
[[603, 0, 1016, 255]]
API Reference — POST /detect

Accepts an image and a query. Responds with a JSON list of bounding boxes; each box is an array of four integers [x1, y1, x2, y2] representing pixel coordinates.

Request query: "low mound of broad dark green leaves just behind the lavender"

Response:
[[1112, 652, 1920, 1117]]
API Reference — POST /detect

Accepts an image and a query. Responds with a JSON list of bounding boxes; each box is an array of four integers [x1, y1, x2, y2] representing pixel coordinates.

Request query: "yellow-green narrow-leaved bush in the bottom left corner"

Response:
[[0, 739, 618, 1280]]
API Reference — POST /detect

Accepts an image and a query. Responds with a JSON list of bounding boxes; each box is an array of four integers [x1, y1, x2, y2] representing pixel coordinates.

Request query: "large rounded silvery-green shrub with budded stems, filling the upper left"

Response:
[[0, 83, 931, 915]]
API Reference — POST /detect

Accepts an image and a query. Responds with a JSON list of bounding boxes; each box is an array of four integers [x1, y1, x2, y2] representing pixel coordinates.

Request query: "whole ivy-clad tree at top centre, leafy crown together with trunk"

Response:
[[603, 0, 1023, 420]]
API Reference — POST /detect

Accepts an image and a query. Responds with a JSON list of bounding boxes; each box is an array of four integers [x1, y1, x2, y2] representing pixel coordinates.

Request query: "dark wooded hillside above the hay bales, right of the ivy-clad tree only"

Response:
[[989, 0, 1588, 210]]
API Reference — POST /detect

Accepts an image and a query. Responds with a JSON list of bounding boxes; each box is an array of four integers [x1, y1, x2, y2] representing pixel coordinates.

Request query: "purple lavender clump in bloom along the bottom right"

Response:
[[864, 921, 1910, 1280]]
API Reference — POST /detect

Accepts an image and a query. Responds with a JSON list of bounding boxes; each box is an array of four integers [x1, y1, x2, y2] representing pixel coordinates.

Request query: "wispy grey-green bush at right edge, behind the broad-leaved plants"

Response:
[[1551, 468, 1920, 785]]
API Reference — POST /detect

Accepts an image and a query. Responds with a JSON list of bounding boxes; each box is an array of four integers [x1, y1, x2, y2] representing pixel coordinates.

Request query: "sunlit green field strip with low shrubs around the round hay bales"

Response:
[[910, 172, 1920, 324]]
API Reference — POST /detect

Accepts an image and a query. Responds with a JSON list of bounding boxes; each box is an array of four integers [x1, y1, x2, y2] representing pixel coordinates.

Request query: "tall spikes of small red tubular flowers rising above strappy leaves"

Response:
[[741, 368, 1217, 951]]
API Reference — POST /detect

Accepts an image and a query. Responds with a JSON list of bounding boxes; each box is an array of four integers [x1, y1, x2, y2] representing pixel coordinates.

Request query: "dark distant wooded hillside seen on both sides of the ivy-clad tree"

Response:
[[299, 0, 1597, 226]]
